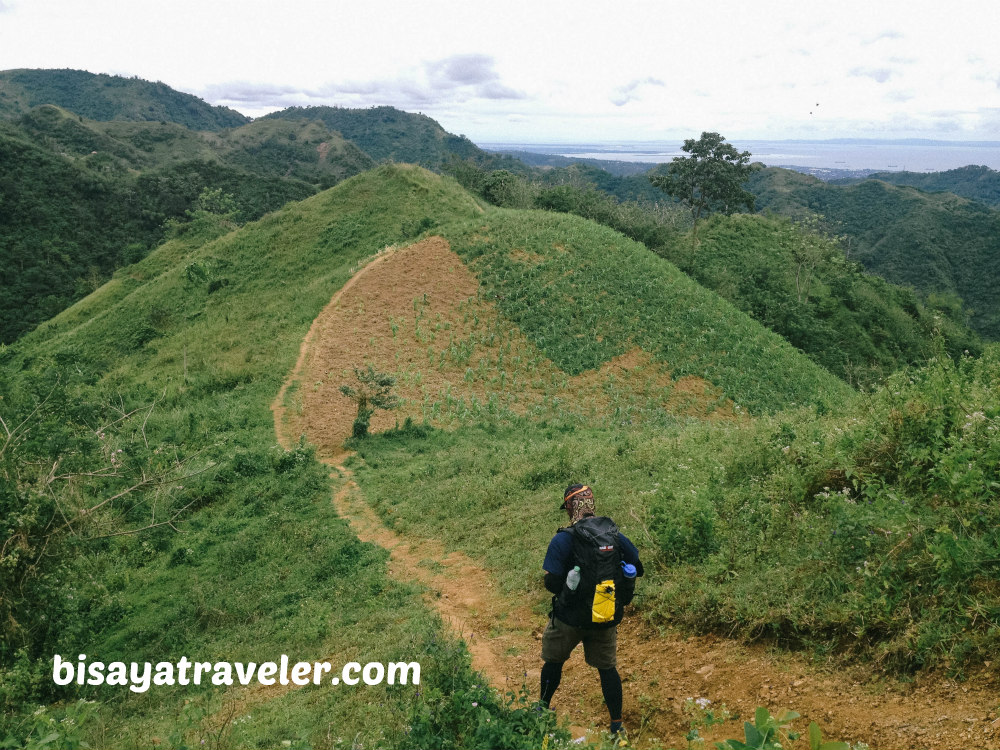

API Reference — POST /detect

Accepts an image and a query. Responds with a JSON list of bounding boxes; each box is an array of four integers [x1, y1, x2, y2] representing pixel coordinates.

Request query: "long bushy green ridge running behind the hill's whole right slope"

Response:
[[456, 165, 981, 386]]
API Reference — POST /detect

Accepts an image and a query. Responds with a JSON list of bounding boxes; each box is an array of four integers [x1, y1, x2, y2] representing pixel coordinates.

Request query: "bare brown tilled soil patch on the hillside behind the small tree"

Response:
[[273, 237, 732, 455]]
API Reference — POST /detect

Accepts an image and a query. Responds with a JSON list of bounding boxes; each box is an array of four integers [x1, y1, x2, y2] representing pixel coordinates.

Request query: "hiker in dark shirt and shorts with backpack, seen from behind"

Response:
[[541, 484, 643, 735]]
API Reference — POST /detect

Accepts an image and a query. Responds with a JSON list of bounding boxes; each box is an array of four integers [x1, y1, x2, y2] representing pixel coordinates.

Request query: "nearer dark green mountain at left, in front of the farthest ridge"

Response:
[[0, 105, 373, 343]]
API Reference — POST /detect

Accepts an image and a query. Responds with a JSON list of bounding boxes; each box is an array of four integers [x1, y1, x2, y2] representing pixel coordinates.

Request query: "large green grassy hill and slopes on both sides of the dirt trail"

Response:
[[0, 165, 1000, 747]]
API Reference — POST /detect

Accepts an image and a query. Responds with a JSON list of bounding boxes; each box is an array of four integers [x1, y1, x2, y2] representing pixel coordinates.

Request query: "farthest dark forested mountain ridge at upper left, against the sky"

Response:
[[0, 69, 250, 130]]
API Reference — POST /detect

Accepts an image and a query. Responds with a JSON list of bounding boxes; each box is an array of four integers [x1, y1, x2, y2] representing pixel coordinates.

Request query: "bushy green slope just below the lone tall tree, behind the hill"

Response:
[[660, 215, 981, 386]]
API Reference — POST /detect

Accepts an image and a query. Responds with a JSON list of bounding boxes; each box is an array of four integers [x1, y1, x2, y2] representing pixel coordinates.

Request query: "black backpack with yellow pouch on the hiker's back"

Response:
[[553, 516, 635, 628]]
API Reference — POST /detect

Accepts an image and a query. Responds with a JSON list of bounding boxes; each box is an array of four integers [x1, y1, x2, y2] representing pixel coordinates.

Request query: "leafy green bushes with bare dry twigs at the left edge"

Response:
[[0, 378, 212, 668]]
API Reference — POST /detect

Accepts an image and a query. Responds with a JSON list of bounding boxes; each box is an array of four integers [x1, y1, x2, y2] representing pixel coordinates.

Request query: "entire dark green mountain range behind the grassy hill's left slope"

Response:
[[0, 70, 516, 342]]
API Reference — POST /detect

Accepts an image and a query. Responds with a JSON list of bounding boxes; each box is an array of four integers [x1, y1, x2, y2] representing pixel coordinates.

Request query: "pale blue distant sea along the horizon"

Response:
[[479, 139, 1000, 172]]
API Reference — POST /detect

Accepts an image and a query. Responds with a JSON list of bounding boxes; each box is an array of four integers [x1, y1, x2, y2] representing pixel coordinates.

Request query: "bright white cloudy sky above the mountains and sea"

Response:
[[0, 0, 1000, 142]]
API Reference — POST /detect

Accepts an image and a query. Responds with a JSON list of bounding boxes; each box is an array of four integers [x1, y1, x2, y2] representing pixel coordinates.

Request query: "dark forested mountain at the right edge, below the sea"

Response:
[[748, 168, 1000, 340]]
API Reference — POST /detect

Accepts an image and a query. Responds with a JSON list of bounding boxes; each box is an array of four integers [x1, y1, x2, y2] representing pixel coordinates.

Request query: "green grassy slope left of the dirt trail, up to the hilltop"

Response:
[[0, 166, 478, 746]]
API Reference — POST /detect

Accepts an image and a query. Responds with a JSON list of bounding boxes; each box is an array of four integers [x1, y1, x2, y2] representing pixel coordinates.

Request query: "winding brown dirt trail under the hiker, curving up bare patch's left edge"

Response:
[[272, 238, 1000, 750]]
